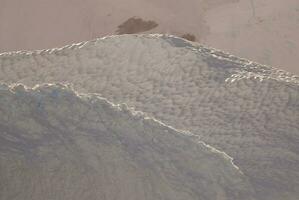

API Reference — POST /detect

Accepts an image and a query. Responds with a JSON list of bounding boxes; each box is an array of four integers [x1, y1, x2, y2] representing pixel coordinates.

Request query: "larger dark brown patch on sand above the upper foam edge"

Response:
[[116, 17, 158, 34]]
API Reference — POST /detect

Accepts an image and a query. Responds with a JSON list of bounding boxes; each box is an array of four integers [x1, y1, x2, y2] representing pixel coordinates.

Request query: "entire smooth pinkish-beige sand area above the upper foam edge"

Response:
[[0, 0, 299, 74]]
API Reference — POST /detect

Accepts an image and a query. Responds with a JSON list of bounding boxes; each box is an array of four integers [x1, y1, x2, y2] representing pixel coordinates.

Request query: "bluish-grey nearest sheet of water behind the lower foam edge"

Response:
[[0, 84, 253, 200]]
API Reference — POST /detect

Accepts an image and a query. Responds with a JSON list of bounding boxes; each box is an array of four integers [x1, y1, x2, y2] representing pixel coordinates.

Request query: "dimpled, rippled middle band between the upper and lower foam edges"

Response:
[[0, 35, 299, 200]]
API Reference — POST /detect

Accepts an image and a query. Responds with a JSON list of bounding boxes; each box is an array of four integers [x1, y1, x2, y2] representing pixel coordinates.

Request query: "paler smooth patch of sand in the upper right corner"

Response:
[[204, 0, 299, 74]]
